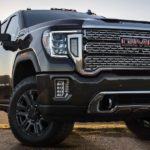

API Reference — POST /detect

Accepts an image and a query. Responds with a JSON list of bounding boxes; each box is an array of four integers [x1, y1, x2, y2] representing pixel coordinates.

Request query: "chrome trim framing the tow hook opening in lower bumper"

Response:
[[87, 91, 150, 114]]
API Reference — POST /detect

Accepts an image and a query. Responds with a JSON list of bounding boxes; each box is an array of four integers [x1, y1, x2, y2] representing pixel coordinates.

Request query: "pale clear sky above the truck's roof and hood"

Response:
[[0, 0, 150, 21]]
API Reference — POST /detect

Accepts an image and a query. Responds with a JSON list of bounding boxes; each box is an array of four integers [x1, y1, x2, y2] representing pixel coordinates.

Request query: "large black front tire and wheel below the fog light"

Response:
[[8, 77, 74, 146]]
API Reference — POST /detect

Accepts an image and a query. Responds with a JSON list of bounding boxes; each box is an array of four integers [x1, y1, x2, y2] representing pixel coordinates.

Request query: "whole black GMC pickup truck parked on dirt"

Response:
[[0, 9, 150, 146]]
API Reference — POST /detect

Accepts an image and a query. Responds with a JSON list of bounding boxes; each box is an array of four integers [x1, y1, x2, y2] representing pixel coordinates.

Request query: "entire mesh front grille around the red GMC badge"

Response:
[[83, 29, 150, 72]]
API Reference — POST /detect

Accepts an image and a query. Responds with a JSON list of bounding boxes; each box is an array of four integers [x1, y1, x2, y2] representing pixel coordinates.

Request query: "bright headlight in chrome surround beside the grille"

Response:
[[43, 31, 79, 57]]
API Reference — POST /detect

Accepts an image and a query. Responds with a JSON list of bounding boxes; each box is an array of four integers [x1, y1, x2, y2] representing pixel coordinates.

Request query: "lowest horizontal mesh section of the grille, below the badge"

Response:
[[84, 56, 150, 71]]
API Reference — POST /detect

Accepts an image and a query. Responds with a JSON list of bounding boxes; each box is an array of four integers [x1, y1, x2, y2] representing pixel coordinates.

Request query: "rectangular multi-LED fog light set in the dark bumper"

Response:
[[55, 79, 69, 98]]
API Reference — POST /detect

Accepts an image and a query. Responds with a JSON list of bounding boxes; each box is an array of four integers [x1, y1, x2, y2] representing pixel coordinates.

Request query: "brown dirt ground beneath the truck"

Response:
[[0, 113, 150, 150]]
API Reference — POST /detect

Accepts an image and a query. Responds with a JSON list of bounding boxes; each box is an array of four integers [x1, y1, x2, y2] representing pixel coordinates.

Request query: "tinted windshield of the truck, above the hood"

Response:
[[24, 10, 100, 27]]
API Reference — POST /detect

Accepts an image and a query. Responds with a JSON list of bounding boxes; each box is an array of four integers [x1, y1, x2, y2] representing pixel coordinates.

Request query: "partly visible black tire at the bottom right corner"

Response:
[[125, 118, 150, 140]]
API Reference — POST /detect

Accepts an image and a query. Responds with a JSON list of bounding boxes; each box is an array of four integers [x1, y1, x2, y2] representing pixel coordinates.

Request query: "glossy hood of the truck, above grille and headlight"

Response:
[[29, 18, 150, 31]]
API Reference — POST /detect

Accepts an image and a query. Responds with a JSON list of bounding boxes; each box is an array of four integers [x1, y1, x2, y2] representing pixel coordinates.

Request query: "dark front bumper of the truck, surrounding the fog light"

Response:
[[37, 73, 150, 121]]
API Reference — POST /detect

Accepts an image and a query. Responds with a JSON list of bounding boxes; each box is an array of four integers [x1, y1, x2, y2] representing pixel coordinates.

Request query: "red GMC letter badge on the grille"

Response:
[[121, 37, 150, 48]]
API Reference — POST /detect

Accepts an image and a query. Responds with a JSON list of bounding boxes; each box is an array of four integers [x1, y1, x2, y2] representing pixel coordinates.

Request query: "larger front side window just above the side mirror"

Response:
[[6, 16, 19, 40]]
